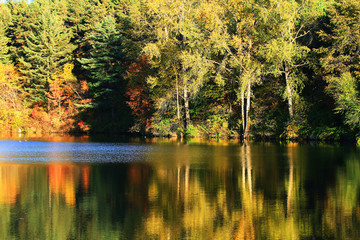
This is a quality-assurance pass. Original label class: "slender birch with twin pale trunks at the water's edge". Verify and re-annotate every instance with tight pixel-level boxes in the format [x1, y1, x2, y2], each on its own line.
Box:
[223, 1, 262, 138]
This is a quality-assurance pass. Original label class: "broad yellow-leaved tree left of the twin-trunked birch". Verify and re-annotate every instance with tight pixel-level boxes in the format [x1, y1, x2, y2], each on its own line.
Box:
[137, 1, 217, 134]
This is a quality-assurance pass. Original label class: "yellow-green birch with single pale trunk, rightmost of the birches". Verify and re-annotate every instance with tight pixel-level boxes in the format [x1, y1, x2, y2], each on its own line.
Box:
[262, 0, 310, 121]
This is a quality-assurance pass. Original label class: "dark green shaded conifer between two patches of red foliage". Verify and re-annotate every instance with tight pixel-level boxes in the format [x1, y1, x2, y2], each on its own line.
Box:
[78, 16, 129, 130]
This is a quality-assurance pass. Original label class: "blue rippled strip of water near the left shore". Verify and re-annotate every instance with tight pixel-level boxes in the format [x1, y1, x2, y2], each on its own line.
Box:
[0, 141, 150, 163]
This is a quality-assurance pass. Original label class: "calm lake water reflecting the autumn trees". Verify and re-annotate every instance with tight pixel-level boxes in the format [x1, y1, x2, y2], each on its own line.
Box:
[0, 138, 360, 239]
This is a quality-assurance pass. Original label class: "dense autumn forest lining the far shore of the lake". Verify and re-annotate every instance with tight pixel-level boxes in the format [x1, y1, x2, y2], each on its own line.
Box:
[0, 0, 360, 140]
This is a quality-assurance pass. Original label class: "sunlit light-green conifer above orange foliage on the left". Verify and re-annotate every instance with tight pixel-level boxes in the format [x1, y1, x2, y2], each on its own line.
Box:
[19, 9, 74, 103]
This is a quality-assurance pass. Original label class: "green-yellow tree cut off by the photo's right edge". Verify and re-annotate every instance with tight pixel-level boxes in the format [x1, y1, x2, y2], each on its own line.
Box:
[319, 0, 360, 133]
